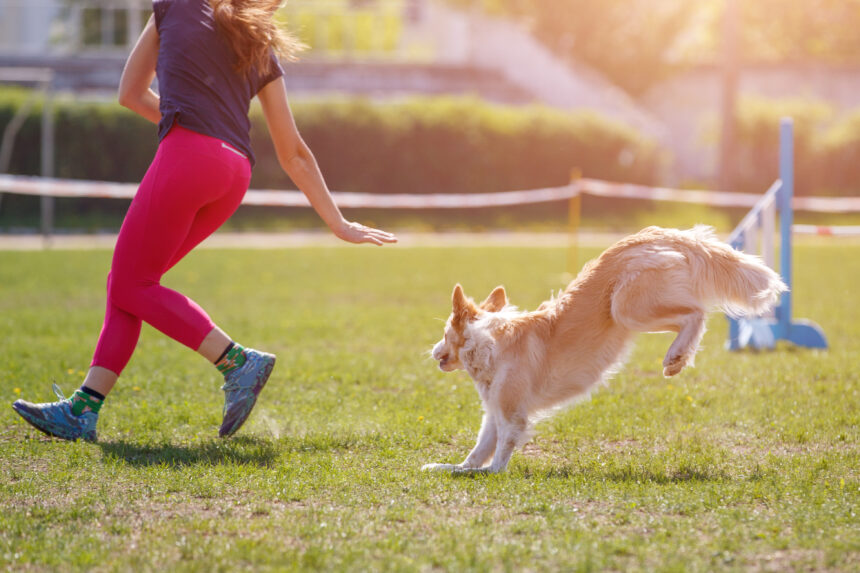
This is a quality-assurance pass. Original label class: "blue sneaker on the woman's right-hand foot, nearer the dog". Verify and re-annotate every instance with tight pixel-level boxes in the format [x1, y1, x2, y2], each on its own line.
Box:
[218, 348, 275, 438]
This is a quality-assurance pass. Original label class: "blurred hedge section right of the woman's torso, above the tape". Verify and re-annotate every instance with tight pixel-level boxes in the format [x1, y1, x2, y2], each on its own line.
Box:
[253, 98, 657, 193]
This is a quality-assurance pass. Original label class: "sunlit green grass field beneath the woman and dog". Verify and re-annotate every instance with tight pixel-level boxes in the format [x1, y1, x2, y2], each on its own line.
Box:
[0, 242, 860, 571]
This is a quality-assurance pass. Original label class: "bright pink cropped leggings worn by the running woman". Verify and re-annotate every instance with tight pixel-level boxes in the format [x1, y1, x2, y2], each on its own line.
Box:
[92, 125, 251, 375]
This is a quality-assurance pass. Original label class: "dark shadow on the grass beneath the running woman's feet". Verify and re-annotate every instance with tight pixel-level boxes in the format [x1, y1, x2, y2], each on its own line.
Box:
[98, 436, 278, 467]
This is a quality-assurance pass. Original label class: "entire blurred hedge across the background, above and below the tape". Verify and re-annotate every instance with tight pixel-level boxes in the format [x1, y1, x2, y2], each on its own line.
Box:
[0, 88, 860, 229]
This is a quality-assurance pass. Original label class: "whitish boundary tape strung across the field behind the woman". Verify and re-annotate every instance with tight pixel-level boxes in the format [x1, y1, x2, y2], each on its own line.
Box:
[0, 174, 860, 213]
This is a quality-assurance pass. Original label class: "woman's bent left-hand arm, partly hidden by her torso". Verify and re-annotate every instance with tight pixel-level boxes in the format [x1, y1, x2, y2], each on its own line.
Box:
[119, 16, 161, 124]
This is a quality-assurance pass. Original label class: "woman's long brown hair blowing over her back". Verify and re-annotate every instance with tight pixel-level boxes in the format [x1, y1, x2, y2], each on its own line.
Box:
[209, 0, 304, 74]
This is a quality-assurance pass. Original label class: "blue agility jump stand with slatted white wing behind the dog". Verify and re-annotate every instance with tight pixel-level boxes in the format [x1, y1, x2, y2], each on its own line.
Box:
[727, 118, 827, 350]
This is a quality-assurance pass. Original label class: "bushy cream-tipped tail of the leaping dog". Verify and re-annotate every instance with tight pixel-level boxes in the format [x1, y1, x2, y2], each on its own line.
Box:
[693, 227, 788, 317]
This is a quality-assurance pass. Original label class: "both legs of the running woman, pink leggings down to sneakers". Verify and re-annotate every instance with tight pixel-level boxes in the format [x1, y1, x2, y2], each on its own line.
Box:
[13, 128, 255, 441]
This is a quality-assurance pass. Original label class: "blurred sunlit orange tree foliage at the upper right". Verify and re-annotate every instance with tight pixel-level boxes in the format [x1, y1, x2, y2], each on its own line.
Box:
[448, 0, 860, 96]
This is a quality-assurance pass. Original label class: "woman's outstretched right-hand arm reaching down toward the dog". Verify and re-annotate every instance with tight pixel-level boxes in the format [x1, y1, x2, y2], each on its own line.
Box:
[257, 78, 397, 245]
